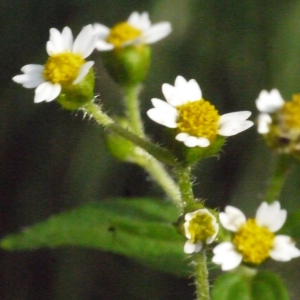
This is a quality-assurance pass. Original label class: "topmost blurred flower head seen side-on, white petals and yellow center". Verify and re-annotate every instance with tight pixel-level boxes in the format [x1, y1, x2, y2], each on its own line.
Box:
[94, 12, 172, 51]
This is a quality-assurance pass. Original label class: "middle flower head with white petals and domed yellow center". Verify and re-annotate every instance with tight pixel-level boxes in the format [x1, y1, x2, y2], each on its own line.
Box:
[147, 76, 253, 147]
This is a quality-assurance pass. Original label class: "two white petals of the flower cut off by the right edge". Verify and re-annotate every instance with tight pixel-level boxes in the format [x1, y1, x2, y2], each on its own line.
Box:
[255, 89, 284, 134]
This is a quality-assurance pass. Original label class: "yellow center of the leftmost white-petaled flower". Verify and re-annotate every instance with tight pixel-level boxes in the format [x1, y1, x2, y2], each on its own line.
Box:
[43, 52, 85, 85]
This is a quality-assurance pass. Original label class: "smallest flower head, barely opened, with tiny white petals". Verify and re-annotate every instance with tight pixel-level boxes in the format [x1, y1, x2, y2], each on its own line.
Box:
[183, 208, 219, 254]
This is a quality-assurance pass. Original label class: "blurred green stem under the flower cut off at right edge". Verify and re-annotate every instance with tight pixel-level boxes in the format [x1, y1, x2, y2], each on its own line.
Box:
[266, 154, 290, 203]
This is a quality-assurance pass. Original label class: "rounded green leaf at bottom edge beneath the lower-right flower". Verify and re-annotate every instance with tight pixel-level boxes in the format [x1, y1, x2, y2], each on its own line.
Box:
[212, 271, 289, 300]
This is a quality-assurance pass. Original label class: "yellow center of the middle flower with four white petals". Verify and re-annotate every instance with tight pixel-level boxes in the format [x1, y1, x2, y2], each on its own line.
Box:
[176, 99, 220, 141]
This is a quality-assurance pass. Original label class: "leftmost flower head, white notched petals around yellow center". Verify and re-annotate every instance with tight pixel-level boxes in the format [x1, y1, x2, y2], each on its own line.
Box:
[13, 25, 96, 103]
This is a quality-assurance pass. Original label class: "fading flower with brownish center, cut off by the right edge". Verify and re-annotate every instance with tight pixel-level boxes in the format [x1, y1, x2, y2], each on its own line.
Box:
[256, 89, 300, 156]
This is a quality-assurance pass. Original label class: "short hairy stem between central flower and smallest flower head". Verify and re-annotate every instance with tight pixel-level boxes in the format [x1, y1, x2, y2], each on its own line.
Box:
[175, 166, 195, 206]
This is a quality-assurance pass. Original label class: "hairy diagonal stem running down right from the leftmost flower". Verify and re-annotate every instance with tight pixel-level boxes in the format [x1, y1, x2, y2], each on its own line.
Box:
[82, 102, 177, 166]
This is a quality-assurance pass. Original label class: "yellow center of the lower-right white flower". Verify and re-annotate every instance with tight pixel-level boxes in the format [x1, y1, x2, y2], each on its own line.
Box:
[233, 219, 275, 264]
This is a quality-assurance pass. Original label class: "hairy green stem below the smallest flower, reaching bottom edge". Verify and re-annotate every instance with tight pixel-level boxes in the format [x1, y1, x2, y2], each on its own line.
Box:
[194, 250, 210, 300]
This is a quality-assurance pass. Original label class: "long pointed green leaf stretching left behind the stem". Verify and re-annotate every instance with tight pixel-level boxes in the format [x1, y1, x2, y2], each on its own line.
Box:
[0, 199, 188, 276]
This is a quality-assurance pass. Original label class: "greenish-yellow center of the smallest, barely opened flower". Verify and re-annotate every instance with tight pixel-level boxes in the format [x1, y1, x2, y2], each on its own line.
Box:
[187, 212, 216, 243]
